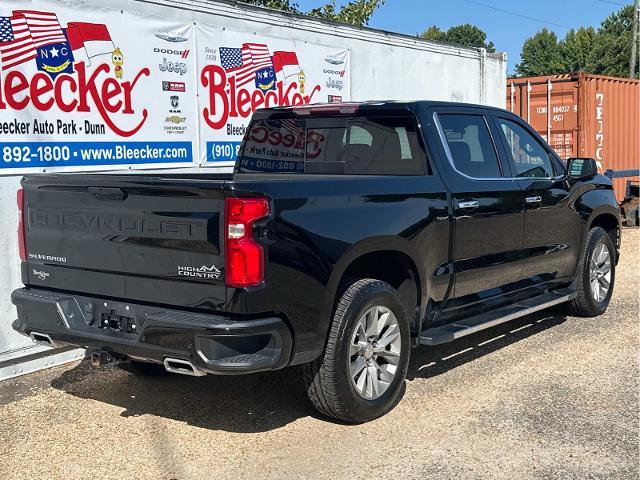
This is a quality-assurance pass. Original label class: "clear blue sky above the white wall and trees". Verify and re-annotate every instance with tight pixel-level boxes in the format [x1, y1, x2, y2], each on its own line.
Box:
[297, 0, 631, 74]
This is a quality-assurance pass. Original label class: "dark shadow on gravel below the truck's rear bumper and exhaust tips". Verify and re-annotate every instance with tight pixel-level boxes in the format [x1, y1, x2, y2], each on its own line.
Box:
[51, 360, 316, 433]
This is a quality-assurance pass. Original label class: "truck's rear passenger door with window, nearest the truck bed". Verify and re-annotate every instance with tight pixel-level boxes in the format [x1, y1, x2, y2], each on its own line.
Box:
[433, 108, 524, 300]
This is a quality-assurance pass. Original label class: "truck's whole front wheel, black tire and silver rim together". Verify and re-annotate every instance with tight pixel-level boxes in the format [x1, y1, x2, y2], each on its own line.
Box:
[568, 227, 616, 317]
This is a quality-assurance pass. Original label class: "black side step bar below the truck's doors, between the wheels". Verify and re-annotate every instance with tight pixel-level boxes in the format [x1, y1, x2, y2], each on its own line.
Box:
[420, 289, 576, 345]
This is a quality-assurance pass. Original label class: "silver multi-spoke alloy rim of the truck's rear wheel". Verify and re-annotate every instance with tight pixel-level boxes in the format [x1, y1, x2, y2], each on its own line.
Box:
[349, 305, 402, 400]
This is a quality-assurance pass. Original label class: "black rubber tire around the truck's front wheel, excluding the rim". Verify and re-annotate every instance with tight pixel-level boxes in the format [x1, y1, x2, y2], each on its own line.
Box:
[567, 227, 616, 317]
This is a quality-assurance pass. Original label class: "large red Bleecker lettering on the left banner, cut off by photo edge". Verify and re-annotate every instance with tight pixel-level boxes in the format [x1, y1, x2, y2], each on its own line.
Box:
[0, 62, 150, 137]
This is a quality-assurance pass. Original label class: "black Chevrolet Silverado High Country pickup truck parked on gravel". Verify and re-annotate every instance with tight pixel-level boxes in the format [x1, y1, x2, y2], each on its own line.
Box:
[12, 101, 620, 422]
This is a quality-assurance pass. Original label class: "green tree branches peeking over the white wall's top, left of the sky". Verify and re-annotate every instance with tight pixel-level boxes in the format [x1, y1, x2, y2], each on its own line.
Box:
[239, 0, 385, 27]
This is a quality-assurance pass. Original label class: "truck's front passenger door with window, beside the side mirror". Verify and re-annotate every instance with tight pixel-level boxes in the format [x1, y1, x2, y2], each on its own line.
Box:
[494, 114, 581, 284]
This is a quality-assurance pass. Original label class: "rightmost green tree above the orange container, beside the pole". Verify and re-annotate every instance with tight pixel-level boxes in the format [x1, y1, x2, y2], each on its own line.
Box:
[591, 5, 633, 77]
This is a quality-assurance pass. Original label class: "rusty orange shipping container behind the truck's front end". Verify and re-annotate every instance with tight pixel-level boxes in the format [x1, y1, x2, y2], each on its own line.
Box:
[506, 73, 640, 200]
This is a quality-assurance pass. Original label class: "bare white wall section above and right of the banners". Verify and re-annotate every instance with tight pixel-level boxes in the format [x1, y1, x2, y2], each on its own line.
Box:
[144, 0, 507, 107]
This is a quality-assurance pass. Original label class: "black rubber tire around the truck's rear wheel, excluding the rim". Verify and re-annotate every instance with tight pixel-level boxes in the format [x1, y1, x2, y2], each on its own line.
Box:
[303, 279, 410, 423]
